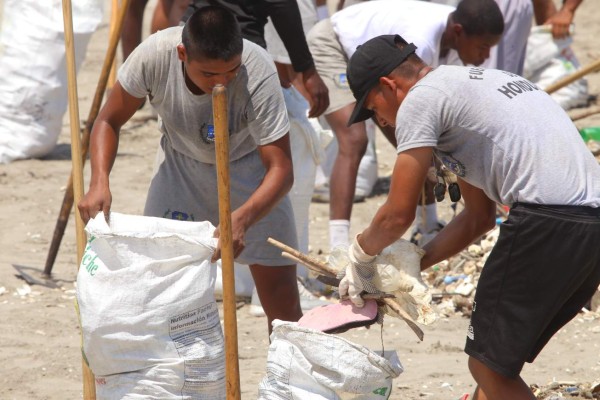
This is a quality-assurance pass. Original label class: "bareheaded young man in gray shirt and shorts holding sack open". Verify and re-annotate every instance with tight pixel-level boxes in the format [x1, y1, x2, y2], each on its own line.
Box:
[79, 7, 302, 332]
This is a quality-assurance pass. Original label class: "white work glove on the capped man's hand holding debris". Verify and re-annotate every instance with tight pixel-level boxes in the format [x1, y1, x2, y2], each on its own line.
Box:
[339, 235, 380, 307]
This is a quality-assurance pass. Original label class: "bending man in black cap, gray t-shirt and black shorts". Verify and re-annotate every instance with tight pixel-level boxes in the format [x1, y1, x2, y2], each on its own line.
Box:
[340, 35, 600, 400]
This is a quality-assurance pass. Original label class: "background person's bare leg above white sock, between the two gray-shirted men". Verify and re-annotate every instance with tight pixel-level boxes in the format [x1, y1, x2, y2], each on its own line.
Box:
[326, 103, 368, 220]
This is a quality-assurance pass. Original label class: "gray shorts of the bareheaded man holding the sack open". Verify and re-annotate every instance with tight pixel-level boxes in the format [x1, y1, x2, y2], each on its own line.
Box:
[144, 136, 298, 266]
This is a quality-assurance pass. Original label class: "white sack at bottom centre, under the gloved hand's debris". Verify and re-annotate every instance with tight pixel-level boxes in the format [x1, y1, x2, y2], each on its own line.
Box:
[258, 320, 403, 400]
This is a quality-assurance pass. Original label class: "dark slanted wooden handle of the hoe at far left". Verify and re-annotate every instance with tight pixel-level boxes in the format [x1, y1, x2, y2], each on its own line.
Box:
[43, 0, 129, 277]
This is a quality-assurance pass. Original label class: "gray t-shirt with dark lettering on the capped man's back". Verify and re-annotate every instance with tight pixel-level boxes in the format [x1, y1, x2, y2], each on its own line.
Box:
[396, 66, 600, 207]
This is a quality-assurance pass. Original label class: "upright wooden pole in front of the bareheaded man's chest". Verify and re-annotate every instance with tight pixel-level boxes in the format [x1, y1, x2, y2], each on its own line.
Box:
[212, 85, 240, 400]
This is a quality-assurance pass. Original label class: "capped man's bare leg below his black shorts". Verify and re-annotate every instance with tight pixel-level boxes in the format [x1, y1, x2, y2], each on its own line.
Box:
[469, 357, 536, 400]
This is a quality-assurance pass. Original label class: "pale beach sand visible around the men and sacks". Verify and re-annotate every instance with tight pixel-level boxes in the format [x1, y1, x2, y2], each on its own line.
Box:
[0, 0, 600, 400]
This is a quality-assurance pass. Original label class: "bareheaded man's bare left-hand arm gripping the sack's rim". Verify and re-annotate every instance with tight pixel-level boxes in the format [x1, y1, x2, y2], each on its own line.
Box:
[77, 81, 144, 223]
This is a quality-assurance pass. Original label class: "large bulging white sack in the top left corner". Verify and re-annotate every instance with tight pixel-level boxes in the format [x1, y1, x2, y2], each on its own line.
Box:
[0, 0, 103, 163]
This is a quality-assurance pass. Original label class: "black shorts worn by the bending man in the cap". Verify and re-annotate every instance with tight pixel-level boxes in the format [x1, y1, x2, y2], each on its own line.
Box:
[465, 203, 600, 378]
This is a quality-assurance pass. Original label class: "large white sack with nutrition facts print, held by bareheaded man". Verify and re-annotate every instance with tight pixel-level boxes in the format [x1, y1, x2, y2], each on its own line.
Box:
[77, 212, 225, 399]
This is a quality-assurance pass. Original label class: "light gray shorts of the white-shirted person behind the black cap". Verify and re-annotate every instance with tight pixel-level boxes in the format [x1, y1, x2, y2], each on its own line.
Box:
[306, 18, 356, 115]
